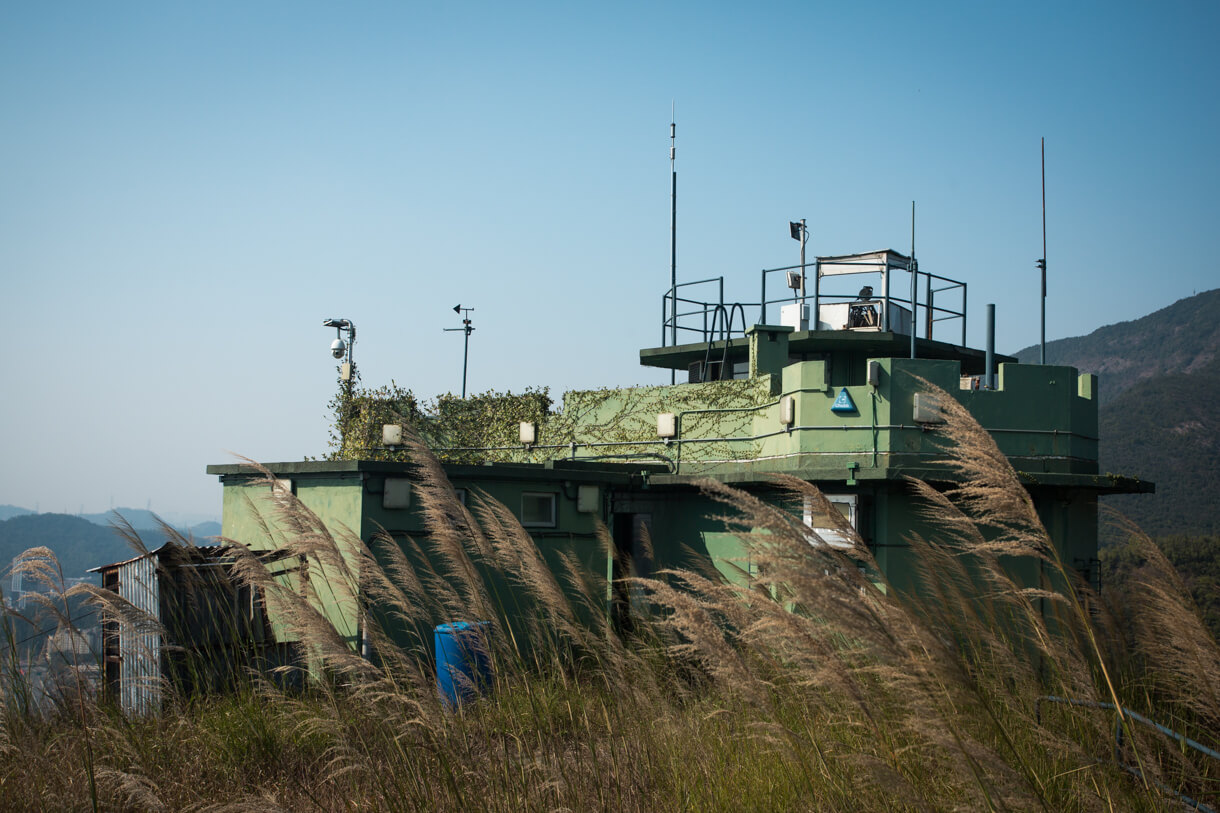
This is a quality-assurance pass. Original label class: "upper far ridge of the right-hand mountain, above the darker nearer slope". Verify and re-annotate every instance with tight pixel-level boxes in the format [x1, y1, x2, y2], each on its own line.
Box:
[1016, 288, 1220, 405]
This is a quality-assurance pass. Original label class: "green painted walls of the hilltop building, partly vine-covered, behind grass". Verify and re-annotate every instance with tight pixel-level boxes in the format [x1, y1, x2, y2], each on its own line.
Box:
[212, 327, 1117, 659]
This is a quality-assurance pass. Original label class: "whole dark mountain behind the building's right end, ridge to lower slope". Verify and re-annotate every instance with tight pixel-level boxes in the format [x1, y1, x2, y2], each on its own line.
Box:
[1016, 289, 1220, 536]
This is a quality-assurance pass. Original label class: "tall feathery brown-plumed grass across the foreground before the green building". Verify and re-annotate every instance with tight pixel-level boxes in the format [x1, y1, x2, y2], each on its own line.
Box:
[0, 399, 1220, 811]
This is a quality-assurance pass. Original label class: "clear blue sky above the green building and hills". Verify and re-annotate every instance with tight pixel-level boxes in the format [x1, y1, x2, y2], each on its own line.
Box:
[0, 1, 1220, 518]
